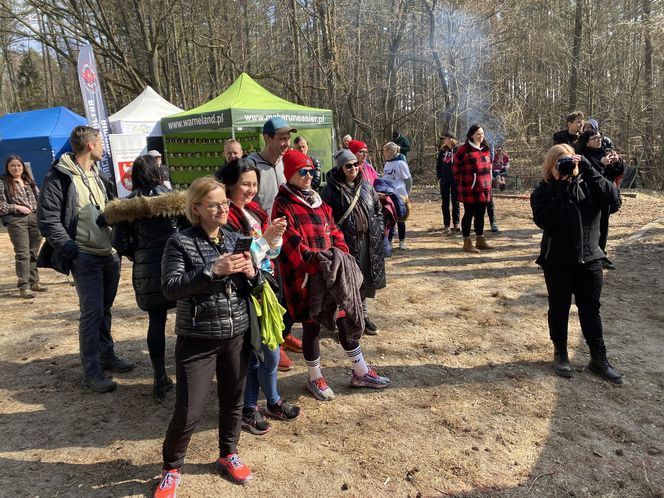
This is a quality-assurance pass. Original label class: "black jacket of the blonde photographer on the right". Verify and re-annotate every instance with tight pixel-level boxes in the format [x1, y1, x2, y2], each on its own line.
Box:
[530, 160, 621, 266]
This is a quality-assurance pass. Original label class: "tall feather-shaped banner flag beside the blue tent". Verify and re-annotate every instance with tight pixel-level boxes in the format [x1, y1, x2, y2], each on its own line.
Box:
[78, 44, 115, 180]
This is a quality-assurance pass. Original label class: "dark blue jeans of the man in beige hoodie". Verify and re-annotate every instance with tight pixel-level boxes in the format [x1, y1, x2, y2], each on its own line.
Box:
[71, 252, 120, 376]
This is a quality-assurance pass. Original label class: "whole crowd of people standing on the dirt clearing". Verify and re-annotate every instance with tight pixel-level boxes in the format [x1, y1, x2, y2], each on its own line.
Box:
[0, 113, 622, 498]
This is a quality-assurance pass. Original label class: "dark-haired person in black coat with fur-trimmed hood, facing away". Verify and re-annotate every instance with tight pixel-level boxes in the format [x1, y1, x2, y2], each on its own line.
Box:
[104, 155, 189, 399]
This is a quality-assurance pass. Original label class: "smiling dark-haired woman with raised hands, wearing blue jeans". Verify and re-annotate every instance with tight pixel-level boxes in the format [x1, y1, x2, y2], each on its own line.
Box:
[221, 159, 300, 435]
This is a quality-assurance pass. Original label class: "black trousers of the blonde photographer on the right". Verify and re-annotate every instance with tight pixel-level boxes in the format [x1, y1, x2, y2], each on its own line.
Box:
[544, 260, 604, 351]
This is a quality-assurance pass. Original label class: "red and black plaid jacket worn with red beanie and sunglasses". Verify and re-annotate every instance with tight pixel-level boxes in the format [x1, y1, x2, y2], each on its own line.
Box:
[272, 185, 348, 322]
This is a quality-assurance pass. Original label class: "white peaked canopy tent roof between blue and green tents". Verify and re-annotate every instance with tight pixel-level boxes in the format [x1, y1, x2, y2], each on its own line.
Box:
[108, 86, 183, 137]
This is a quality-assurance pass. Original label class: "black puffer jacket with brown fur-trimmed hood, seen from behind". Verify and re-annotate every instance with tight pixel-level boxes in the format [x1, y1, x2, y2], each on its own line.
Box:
[104, 185, 189, 311]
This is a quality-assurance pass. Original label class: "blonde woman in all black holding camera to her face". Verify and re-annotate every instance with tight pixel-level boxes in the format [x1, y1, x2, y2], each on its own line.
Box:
[530, 144, 622, 384]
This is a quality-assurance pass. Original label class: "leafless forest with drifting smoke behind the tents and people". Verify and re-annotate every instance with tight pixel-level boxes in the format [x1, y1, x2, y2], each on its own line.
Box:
[0, 0, 664, 188]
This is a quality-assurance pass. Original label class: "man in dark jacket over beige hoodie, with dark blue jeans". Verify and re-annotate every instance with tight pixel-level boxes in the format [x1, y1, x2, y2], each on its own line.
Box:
[37, 126, 134, 393]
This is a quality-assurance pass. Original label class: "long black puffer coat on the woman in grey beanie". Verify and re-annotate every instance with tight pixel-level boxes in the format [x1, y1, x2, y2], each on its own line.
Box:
[321, 168, 386, 289]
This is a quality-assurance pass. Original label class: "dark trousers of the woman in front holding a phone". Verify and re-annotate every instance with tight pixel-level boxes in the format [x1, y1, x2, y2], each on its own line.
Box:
[163, 334, 250, 470]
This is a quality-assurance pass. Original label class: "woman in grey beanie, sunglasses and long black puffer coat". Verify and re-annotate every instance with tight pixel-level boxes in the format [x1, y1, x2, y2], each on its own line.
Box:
[321, 149, 385, 335]
